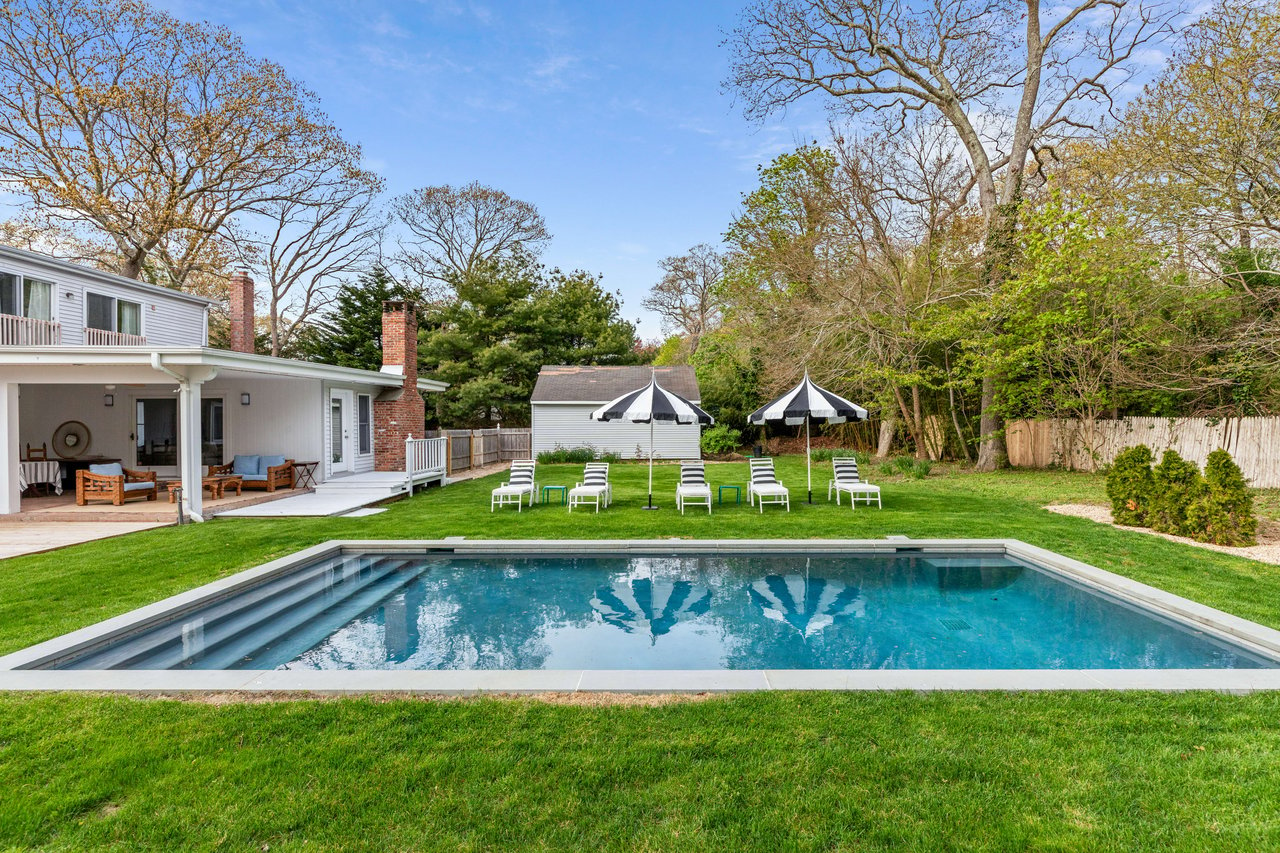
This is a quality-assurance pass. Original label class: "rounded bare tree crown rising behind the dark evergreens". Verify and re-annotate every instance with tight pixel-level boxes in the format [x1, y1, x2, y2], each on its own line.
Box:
[392, 182, 552, 289]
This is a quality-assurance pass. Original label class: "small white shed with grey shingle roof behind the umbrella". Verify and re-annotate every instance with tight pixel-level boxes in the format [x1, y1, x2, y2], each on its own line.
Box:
[530, 365, 701, 459]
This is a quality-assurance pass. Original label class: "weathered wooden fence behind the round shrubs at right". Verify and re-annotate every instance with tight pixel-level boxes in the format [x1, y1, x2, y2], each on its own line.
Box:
[1005, 418, 1280, 489]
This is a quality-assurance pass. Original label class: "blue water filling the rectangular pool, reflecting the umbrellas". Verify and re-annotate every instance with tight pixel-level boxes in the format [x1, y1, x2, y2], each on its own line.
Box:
[59, 555, 1276, 670]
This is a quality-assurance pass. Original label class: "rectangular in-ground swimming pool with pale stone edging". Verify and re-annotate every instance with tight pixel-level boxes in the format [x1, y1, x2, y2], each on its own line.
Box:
[0, 540, 1280, 685]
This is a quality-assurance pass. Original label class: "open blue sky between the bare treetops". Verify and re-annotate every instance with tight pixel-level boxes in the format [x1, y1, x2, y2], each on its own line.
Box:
[157, 0, 826, 338]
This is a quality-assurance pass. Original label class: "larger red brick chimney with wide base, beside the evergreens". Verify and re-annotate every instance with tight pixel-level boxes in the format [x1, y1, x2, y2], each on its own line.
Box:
[374, 300, 426, 471]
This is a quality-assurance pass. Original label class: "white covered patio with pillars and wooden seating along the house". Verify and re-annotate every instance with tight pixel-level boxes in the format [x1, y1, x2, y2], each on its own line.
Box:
[0, 347, 439, 523]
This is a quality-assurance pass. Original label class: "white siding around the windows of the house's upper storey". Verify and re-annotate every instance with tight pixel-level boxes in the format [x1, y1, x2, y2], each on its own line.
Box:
[0, 255, 207, 347]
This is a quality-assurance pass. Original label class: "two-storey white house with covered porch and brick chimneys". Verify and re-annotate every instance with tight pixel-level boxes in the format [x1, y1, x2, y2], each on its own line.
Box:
[0, 246, 447, 520]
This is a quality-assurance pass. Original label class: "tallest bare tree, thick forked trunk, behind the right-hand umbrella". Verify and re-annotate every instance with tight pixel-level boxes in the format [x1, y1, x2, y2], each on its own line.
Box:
[727, 0, 1172, 470]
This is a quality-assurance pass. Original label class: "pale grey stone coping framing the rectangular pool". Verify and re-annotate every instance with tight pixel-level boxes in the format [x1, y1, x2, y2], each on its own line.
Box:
[0, 537, 1280, 695]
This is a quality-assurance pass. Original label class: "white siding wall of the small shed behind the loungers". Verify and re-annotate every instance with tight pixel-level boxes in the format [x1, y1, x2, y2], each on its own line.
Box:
[531, 401, 701, 460]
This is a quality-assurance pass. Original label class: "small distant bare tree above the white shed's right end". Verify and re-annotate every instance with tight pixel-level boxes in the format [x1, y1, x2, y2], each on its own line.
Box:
[643, 243, 724, 356]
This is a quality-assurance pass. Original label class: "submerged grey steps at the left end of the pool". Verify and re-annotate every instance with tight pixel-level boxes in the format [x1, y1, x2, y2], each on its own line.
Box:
[73, 557, 412, 670]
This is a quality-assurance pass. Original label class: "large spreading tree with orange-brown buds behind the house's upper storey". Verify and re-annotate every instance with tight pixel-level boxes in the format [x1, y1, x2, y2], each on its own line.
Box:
[0, 0, 360, 287]
